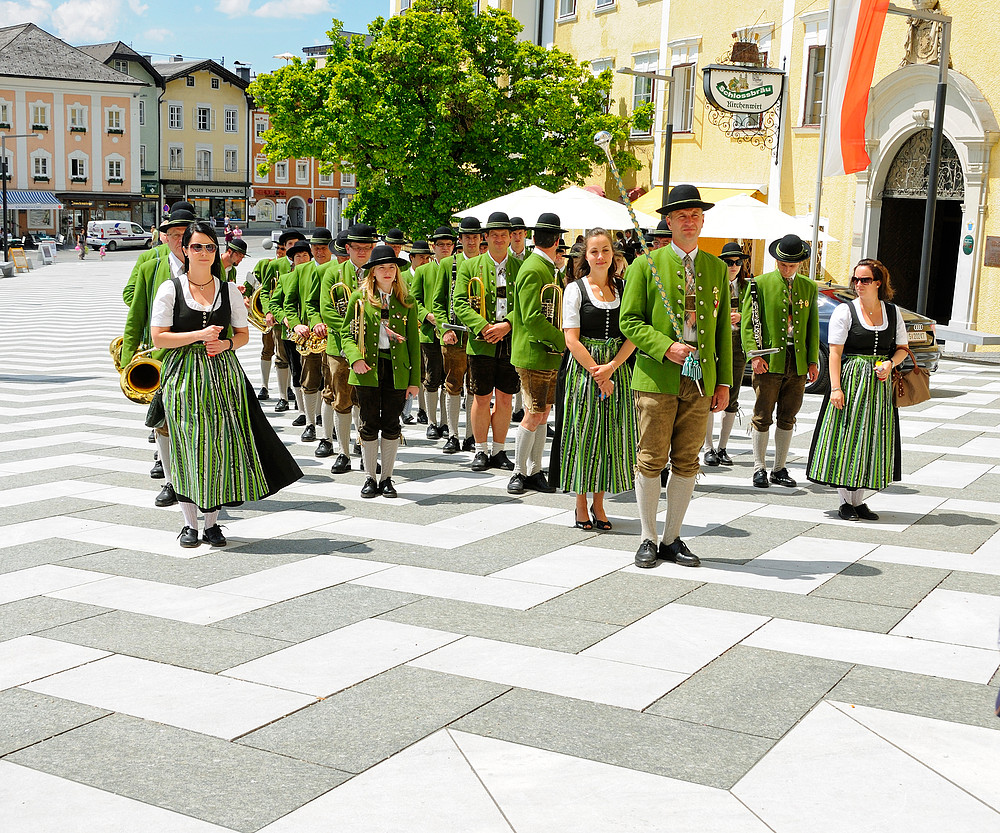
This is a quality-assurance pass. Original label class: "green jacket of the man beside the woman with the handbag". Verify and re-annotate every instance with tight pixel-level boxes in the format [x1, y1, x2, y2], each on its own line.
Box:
[740, 269, 819, 376]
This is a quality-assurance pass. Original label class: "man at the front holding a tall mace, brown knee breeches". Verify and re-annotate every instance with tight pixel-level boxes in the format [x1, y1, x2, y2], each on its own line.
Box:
[620, 185, 733, 567]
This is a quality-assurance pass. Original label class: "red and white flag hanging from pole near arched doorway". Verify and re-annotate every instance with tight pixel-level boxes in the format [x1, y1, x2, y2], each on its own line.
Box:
[823, 0, 889, 176]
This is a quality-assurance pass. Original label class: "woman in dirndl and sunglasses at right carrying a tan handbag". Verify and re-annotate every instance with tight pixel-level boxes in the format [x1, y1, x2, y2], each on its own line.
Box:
[806, 258, 907, 521]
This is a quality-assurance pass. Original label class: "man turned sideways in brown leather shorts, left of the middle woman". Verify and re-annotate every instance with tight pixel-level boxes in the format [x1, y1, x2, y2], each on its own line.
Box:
[507, 213, 566, 495]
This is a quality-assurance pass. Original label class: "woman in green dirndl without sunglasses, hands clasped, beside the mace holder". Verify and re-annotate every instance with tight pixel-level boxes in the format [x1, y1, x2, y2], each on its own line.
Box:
[550, 228, 639, 531]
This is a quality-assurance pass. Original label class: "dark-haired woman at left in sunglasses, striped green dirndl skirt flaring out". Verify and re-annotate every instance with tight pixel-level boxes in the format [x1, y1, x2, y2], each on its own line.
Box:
[150, 221, 302, 547]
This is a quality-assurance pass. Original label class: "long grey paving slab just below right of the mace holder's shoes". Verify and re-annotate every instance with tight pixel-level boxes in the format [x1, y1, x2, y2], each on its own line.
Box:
[684, 584, 910, 633]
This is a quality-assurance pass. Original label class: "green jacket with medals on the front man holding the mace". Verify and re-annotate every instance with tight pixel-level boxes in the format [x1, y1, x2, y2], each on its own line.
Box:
[619, 246, 733, 396]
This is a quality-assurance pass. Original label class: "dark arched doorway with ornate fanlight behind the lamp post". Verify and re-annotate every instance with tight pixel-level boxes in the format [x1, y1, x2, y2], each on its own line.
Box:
[877, 129, 965, 324]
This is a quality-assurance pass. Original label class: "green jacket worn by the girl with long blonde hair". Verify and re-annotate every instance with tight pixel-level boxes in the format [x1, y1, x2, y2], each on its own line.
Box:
[340, 289, 420, 390]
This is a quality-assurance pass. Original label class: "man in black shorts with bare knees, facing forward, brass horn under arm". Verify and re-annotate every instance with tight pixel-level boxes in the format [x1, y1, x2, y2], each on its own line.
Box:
[452, 211, 521, 471]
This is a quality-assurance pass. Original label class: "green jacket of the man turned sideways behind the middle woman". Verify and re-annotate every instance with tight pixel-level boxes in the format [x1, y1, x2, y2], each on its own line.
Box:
[507, 252, 566, 370]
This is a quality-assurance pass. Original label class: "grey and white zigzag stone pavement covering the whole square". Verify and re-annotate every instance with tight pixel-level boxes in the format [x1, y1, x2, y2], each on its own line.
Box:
[0, 255, 1000, 833]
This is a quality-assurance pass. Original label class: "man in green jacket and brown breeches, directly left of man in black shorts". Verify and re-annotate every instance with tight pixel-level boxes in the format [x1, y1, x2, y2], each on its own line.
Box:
[424, 217, 483, 454]
